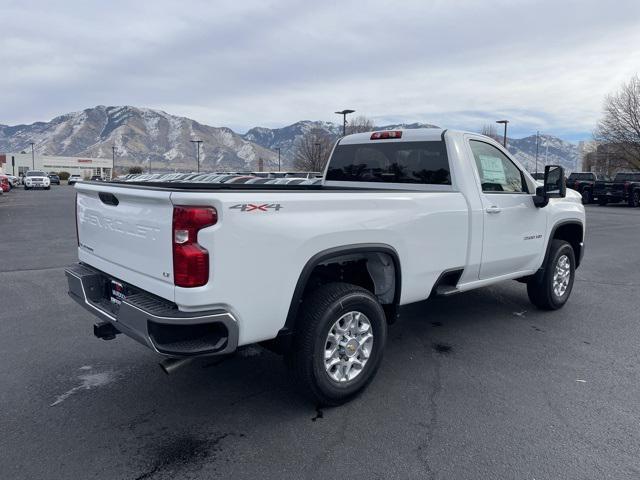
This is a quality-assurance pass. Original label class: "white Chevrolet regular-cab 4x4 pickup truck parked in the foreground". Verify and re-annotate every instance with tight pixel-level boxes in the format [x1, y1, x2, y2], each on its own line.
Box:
[66, 129, 585, 404]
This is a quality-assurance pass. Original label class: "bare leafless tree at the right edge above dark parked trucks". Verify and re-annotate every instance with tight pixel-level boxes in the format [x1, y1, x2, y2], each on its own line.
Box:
[593, 74, 640, 170]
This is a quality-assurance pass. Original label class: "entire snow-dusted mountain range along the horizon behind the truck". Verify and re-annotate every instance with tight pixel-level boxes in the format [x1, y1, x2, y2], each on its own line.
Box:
[0, 105, 578, 171]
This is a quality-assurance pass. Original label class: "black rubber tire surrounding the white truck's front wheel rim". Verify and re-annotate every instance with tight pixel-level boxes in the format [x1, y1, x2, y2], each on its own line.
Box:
[527, 240, 576, 310]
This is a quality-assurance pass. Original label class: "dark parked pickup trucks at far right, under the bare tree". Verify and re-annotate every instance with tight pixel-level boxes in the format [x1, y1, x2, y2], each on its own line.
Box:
[567, 172, 640, 207]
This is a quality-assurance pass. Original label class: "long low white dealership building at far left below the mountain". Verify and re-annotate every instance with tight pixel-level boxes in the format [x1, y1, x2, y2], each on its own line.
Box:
[0, 152, 113, 179]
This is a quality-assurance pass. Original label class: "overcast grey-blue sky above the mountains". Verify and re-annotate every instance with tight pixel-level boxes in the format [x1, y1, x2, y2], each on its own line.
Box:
[0, 0, 640, 140]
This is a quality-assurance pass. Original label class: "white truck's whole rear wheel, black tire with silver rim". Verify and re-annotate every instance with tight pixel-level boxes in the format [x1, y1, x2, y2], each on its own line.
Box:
[285, 283, 387, 405]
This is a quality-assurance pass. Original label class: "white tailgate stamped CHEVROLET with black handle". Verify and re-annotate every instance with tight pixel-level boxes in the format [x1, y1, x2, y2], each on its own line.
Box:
[76, 183, 174, 300]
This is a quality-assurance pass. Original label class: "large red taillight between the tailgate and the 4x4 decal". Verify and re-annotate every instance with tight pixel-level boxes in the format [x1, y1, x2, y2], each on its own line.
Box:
[173, 206, 218, 288]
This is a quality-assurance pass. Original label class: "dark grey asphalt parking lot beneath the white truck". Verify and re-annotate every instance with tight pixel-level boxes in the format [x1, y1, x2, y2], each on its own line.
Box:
[0, 186, 640, 480]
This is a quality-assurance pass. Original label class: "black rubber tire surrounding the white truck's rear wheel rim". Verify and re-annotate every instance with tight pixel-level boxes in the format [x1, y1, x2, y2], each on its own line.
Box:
[285, 283, 387, 406]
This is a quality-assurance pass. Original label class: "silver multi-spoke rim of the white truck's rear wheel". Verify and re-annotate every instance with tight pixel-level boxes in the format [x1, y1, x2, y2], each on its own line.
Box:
[324, 312, 373, 383]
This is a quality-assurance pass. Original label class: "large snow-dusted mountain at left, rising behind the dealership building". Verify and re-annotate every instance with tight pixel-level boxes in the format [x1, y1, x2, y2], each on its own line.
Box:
[0, 105, 277, 170]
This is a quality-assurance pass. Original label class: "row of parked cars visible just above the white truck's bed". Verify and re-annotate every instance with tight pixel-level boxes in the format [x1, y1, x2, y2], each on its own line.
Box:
[115, 172, 322, 185]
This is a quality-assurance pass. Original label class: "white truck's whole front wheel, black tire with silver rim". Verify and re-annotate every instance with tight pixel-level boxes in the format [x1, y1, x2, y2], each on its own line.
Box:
[527, 240, 576, 310]
